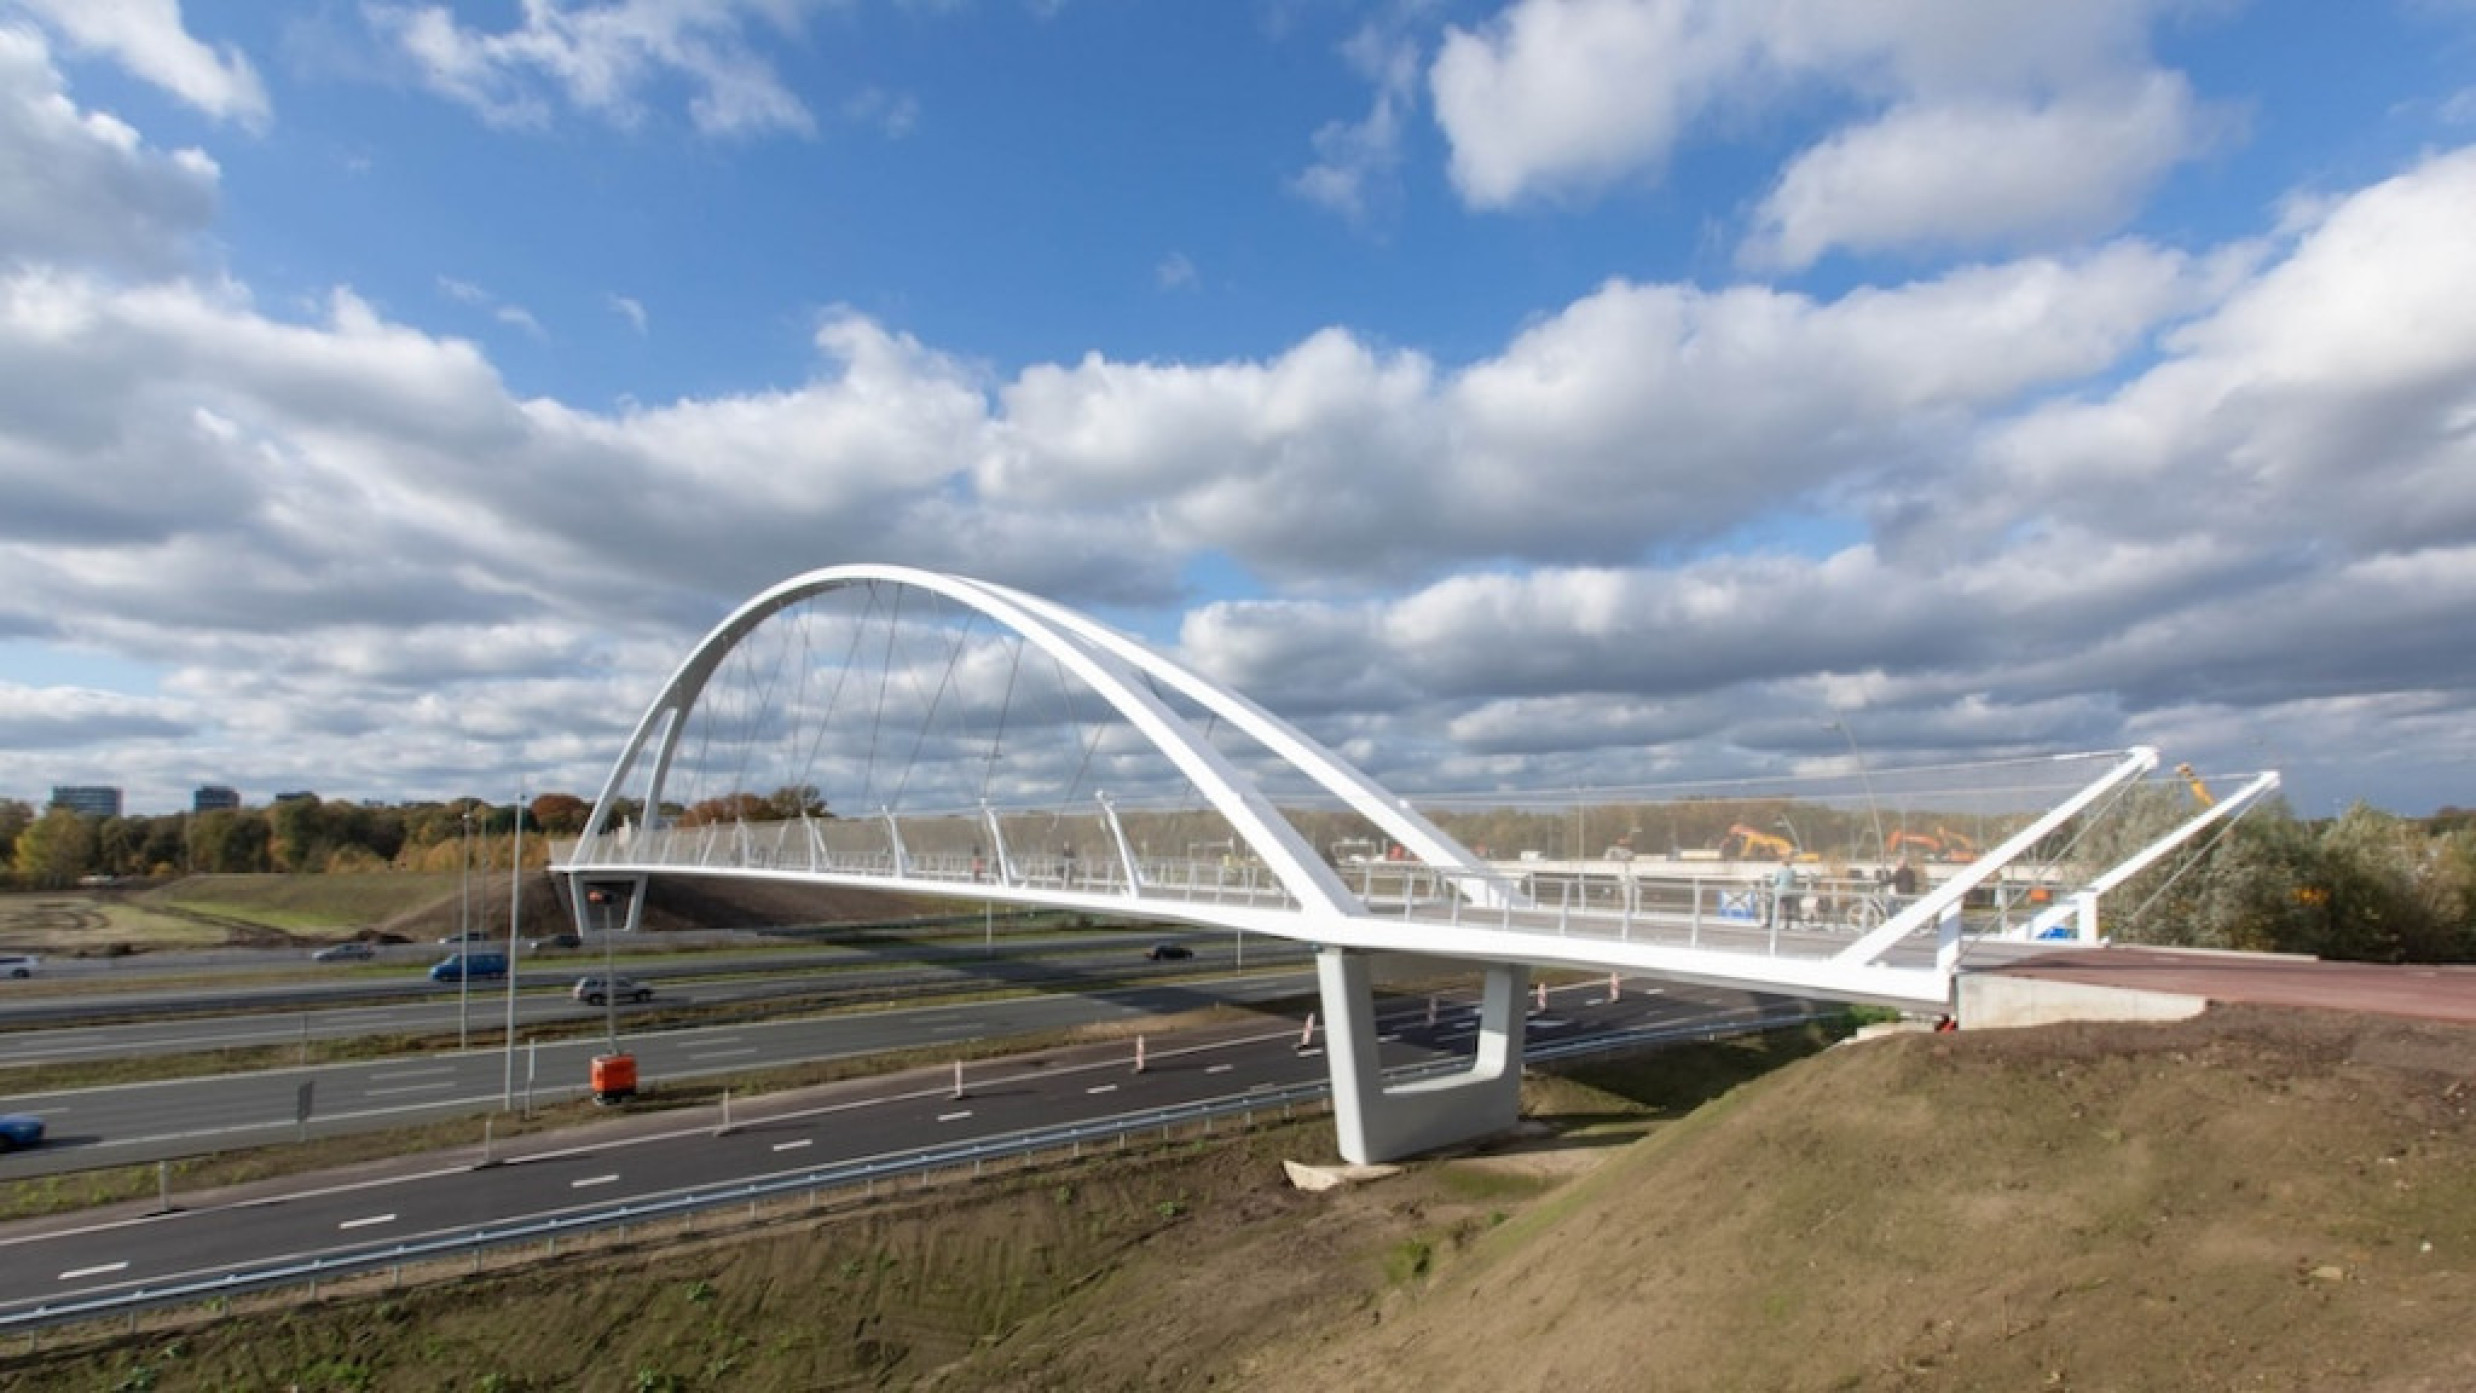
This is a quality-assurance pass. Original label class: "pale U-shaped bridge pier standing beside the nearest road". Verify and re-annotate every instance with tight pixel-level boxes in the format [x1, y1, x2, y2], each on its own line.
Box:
[1315, 948, 1530, 1165]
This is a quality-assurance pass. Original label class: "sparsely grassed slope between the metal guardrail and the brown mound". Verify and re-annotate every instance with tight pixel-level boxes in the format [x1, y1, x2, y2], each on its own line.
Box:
[0, 1032, 1820, 1391]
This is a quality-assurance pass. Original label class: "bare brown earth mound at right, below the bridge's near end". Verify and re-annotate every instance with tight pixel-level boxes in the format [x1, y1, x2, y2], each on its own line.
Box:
[1283, 1009, 2476, 1393]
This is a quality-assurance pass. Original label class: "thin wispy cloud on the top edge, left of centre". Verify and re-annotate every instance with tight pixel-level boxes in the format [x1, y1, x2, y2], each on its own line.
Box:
[366, 0, 817, 136]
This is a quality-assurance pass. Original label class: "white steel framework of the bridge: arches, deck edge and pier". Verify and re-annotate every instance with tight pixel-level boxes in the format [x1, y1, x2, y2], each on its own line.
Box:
[555, 564, 2157, 1163]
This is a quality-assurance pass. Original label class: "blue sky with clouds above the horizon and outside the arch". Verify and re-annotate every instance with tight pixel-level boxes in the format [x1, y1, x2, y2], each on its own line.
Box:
[0, 0, 2476, 817]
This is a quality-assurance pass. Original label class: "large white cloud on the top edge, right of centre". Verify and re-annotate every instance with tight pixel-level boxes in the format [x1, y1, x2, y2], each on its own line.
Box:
[1429, 0, 2223, 267]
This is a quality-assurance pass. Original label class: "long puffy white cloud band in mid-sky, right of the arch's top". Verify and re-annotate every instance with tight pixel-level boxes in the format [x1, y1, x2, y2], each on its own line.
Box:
[980, 245, 2196, 584]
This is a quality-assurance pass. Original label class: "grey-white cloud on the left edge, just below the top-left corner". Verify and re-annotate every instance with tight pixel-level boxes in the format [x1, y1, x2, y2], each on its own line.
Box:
[0, 25, 220, 275]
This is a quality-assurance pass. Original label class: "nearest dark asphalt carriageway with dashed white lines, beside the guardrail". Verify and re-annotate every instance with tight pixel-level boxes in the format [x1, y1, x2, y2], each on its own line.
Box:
[0, 987, 1807, 1311]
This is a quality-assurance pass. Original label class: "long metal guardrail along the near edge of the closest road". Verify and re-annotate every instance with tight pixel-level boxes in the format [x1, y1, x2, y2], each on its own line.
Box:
[0, 1012, 1830, 1334]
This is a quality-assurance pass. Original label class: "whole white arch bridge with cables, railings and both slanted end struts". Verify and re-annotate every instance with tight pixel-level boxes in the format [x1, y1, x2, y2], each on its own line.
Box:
[552, 564, 2275, 1160]
